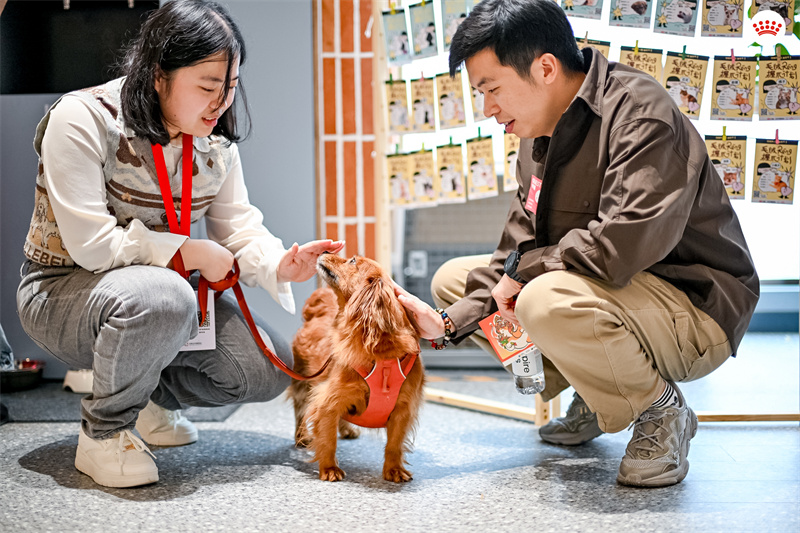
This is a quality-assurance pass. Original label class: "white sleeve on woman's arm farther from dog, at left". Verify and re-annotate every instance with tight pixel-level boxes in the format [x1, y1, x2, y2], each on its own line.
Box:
[41, 96, 186, 272]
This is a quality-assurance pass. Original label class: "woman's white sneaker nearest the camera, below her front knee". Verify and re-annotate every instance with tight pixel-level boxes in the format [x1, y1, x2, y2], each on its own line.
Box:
[75, 427, 158, 487]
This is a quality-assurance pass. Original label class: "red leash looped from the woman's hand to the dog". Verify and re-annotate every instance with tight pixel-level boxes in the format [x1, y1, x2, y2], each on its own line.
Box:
[172, 256, 331, 381]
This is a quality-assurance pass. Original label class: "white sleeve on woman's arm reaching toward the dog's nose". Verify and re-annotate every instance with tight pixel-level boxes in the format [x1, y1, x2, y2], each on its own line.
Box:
[205, 144, 295, 314]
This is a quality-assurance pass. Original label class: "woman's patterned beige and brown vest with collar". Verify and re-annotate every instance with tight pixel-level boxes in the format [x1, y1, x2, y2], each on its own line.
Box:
[24, 78, 231, 266]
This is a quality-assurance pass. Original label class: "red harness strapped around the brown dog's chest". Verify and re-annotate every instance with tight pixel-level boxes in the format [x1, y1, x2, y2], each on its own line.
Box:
[342, 353, 417, 428]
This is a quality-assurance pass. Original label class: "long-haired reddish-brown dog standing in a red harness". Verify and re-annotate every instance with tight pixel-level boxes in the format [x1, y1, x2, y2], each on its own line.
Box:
[289, 254, 425, 483]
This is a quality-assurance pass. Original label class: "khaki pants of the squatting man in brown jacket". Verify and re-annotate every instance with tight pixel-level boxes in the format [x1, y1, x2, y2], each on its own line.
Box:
[431, 255, 732, 433]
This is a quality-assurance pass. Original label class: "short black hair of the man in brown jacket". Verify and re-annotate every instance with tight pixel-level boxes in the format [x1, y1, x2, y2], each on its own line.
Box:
[450, 0, 583, 80]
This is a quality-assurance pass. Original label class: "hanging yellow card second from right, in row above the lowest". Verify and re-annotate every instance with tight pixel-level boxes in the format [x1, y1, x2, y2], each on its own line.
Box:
[711, 56, 758, 120]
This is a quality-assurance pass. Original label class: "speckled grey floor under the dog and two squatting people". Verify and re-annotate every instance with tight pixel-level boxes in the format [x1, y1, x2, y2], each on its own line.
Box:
[0, 334, 800, 533]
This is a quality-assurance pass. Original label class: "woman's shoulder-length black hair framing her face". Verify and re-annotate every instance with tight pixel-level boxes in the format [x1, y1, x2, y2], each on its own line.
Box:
[120, 0, 250, 145]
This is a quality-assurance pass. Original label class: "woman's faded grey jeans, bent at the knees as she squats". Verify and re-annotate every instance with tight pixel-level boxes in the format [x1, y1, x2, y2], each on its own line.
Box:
[17, 262, 292, 439]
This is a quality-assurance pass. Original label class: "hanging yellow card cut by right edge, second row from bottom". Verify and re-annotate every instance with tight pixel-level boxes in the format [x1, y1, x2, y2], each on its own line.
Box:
[758, 56, 800, 120]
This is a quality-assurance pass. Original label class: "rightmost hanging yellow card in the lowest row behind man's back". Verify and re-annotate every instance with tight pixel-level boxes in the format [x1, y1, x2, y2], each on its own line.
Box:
[753, 139, 797, 204]
